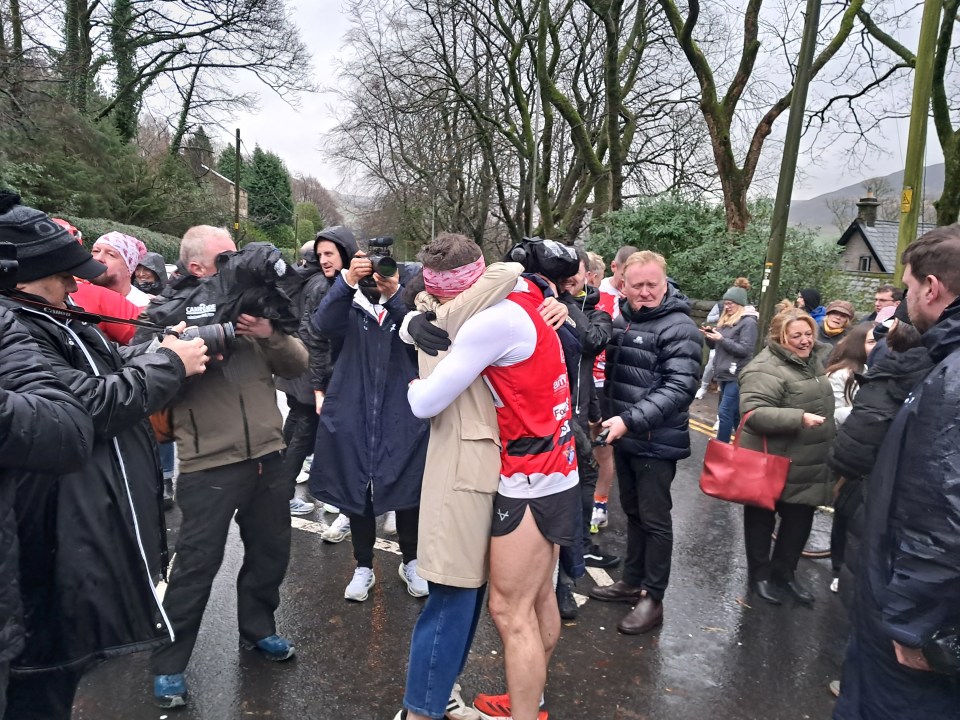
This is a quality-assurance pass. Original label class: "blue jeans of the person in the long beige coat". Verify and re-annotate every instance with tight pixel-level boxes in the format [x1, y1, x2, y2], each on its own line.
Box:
[403, 583, 486, 718]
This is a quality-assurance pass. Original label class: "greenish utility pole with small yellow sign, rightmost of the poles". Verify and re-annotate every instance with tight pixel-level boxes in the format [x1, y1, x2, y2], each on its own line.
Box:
[893, 0, 942, 284]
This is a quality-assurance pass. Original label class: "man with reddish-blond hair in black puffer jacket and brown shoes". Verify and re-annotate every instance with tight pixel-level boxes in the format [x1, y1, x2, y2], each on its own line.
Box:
[590, 251, 702, 635]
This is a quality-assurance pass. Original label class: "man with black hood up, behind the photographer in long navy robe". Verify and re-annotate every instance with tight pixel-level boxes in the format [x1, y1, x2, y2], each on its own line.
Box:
[277, 225, 357, 515]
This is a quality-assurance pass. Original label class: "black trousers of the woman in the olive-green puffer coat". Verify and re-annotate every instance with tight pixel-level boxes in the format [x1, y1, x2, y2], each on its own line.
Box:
[743, 502, 816, 580]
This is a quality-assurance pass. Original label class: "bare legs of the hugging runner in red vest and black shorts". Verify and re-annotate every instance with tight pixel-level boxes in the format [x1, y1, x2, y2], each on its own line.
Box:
[490, 508, 560, 720]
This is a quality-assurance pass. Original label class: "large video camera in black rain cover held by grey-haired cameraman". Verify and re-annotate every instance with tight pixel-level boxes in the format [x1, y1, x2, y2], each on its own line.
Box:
[147, 242, 303, 335]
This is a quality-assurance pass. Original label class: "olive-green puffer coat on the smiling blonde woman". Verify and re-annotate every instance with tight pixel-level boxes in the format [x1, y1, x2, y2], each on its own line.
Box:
[740, 343, 836, 505]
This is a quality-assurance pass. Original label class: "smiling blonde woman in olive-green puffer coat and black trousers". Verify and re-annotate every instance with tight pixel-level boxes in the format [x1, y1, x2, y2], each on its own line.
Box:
[740, 308, 835, 605]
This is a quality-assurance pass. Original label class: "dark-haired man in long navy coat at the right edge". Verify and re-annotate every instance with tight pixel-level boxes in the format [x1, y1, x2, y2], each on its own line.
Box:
[834, 225, 960, 720]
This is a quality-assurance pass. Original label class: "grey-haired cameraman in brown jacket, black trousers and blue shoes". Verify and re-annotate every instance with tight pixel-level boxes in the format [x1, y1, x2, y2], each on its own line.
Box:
[147, 225, 307, 707]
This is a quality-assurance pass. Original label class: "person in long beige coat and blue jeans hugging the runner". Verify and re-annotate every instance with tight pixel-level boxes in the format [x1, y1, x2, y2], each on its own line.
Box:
[396, 243, 523, 720]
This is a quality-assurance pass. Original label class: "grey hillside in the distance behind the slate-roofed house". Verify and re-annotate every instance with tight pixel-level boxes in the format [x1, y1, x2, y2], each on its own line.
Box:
[790, 163, 943, 232]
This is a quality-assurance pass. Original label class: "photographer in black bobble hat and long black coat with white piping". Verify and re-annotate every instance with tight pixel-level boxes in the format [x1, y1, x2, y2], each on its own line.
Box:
[0, 193, 207, 720]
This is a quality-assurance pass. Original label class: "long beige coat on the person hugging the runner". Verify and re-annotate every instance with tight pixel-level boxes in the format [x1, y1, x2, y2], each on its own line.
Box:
[417, 263, 523, 588]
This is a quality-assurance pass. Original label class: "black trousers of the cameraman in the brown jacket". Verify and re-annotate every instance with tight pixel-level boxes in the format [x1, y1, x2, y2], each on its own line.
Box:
[150, 453, 290, 675]
